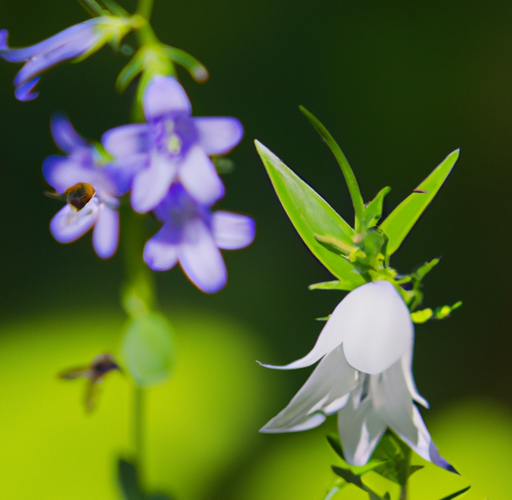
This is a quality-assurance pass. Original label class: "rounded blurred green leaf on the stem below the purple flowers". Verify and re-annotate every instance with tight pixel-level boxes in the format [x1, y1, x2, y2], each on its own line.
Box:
[121, 312, 175, 387]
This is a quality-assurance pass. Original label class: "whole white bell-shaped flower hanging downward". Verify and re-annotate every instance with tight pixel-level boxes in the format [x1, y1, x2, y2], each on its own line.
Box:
[261, 282, 453, 470]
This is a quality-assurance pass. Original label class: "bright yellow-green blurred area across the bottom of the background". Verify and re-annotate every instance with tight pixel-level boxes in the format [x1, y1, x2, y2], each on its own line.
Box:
[0, 310, 512, 500]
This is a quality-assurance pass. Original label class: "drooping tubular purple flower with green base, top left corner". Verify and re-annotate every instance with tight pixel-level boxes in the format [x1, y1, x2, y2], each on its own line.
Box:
[0, 16, 132, 101]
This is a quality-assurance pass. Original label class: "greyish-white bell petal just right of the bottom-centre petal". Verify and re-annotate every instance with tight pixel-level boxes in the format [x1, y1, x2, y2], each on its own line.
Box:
[370, 360, 418, 442]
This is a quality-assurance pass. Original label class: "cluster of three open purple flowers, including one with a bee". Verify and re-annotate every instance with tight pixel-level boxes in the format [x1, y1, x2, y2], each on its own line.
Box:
[43, 76, 254, 293]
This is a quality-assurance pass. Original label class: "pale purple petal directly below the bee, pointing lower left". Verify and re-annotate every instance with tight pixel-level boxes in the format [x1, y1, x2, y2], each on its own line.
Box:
[50, 199, 98, 243]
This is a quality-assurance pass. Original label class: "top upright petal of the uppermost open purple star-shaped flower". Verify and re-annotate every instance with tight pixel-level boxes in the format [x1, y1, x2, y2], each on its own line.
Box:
[143, 76, 192, 121]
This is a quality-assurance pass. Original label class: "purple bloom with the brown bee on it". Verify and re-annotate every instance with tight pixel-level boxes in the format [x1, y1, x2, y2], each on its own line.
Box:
[43, 117, 131, 259]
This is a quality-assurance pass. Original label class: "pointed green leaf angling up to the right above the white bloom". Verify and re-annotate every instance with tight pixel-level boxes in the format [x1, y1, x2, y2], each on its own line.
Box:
[380, 149, 459, 255]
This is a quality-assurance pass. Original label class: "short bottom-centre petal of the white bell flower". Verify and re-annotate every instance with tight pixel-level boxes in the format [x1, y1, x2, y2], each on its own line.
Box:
[338, 398, 386, 465]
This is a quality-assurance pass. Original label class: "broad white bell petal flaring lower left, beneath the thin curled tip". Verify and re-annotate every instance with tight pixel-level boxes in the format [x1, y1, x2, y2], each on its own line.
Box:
[260, 346, 357, 433]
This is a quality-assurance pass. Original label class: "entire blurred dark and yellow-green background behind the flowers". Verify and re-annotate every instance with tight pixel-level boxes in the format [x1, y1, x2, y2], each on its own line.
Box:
[0, 0, 512, 500]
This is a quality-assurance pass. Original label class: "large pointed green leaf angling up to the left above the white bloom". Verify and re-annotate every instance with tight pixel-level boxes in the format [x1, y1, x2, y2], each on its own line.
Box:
[255, 141, 365, 286]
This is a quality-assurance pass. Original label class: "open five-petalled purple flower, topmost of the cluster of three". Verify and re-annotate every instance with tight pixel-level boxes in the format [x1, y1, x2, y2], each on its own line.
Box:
[103, 76, 243, 213]
